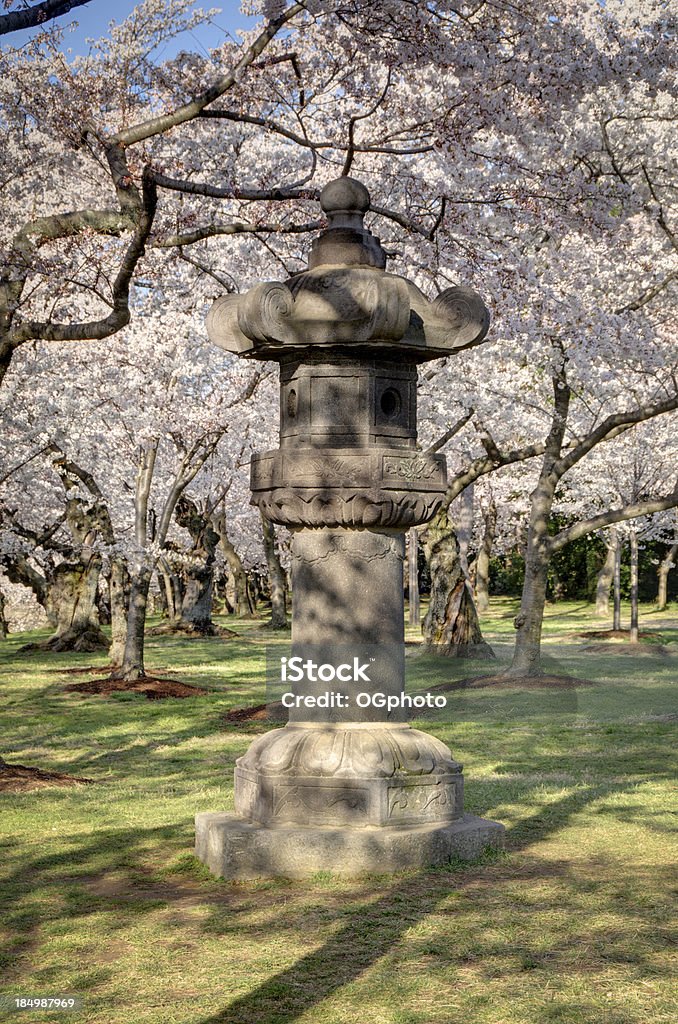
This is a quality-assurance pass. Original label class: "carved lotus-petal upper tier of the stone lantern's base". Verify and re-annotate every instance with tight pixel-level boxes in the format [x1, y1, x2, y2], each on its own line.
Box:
[236, 722, 464, 827]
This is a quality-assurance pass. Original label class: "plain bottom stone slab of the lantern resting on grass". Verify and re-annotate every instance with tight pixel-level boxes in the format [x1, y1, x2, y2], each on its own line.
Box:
[196, 811, 505, 881]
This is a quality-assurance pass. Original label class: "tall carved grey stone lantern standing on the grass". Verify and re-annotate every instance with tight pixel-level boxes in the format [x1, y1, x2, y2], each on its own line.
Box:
[196, 177, 504, 879]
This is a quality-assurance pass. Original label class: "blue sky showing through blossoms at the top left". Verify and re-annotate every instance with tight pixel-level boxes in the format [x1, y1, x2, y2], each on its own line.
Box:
[7, 0, 255, 58]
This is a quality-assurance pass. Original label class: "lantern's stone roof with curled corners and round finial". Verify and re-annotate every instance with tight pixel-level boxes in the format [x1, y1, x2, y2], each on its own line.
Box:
[207, 176, 490, 362]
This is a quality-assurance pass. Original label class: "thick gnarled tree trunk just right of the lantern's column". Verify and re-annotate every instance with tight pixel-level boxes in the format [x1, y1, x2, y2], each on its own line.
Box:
[422, 510, 495, 657]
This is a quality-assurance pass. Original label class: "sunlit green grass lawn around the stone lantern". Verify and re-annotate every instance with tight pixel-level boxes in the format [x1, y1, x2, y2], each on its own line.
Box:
[0, 600, 678, 1024]
